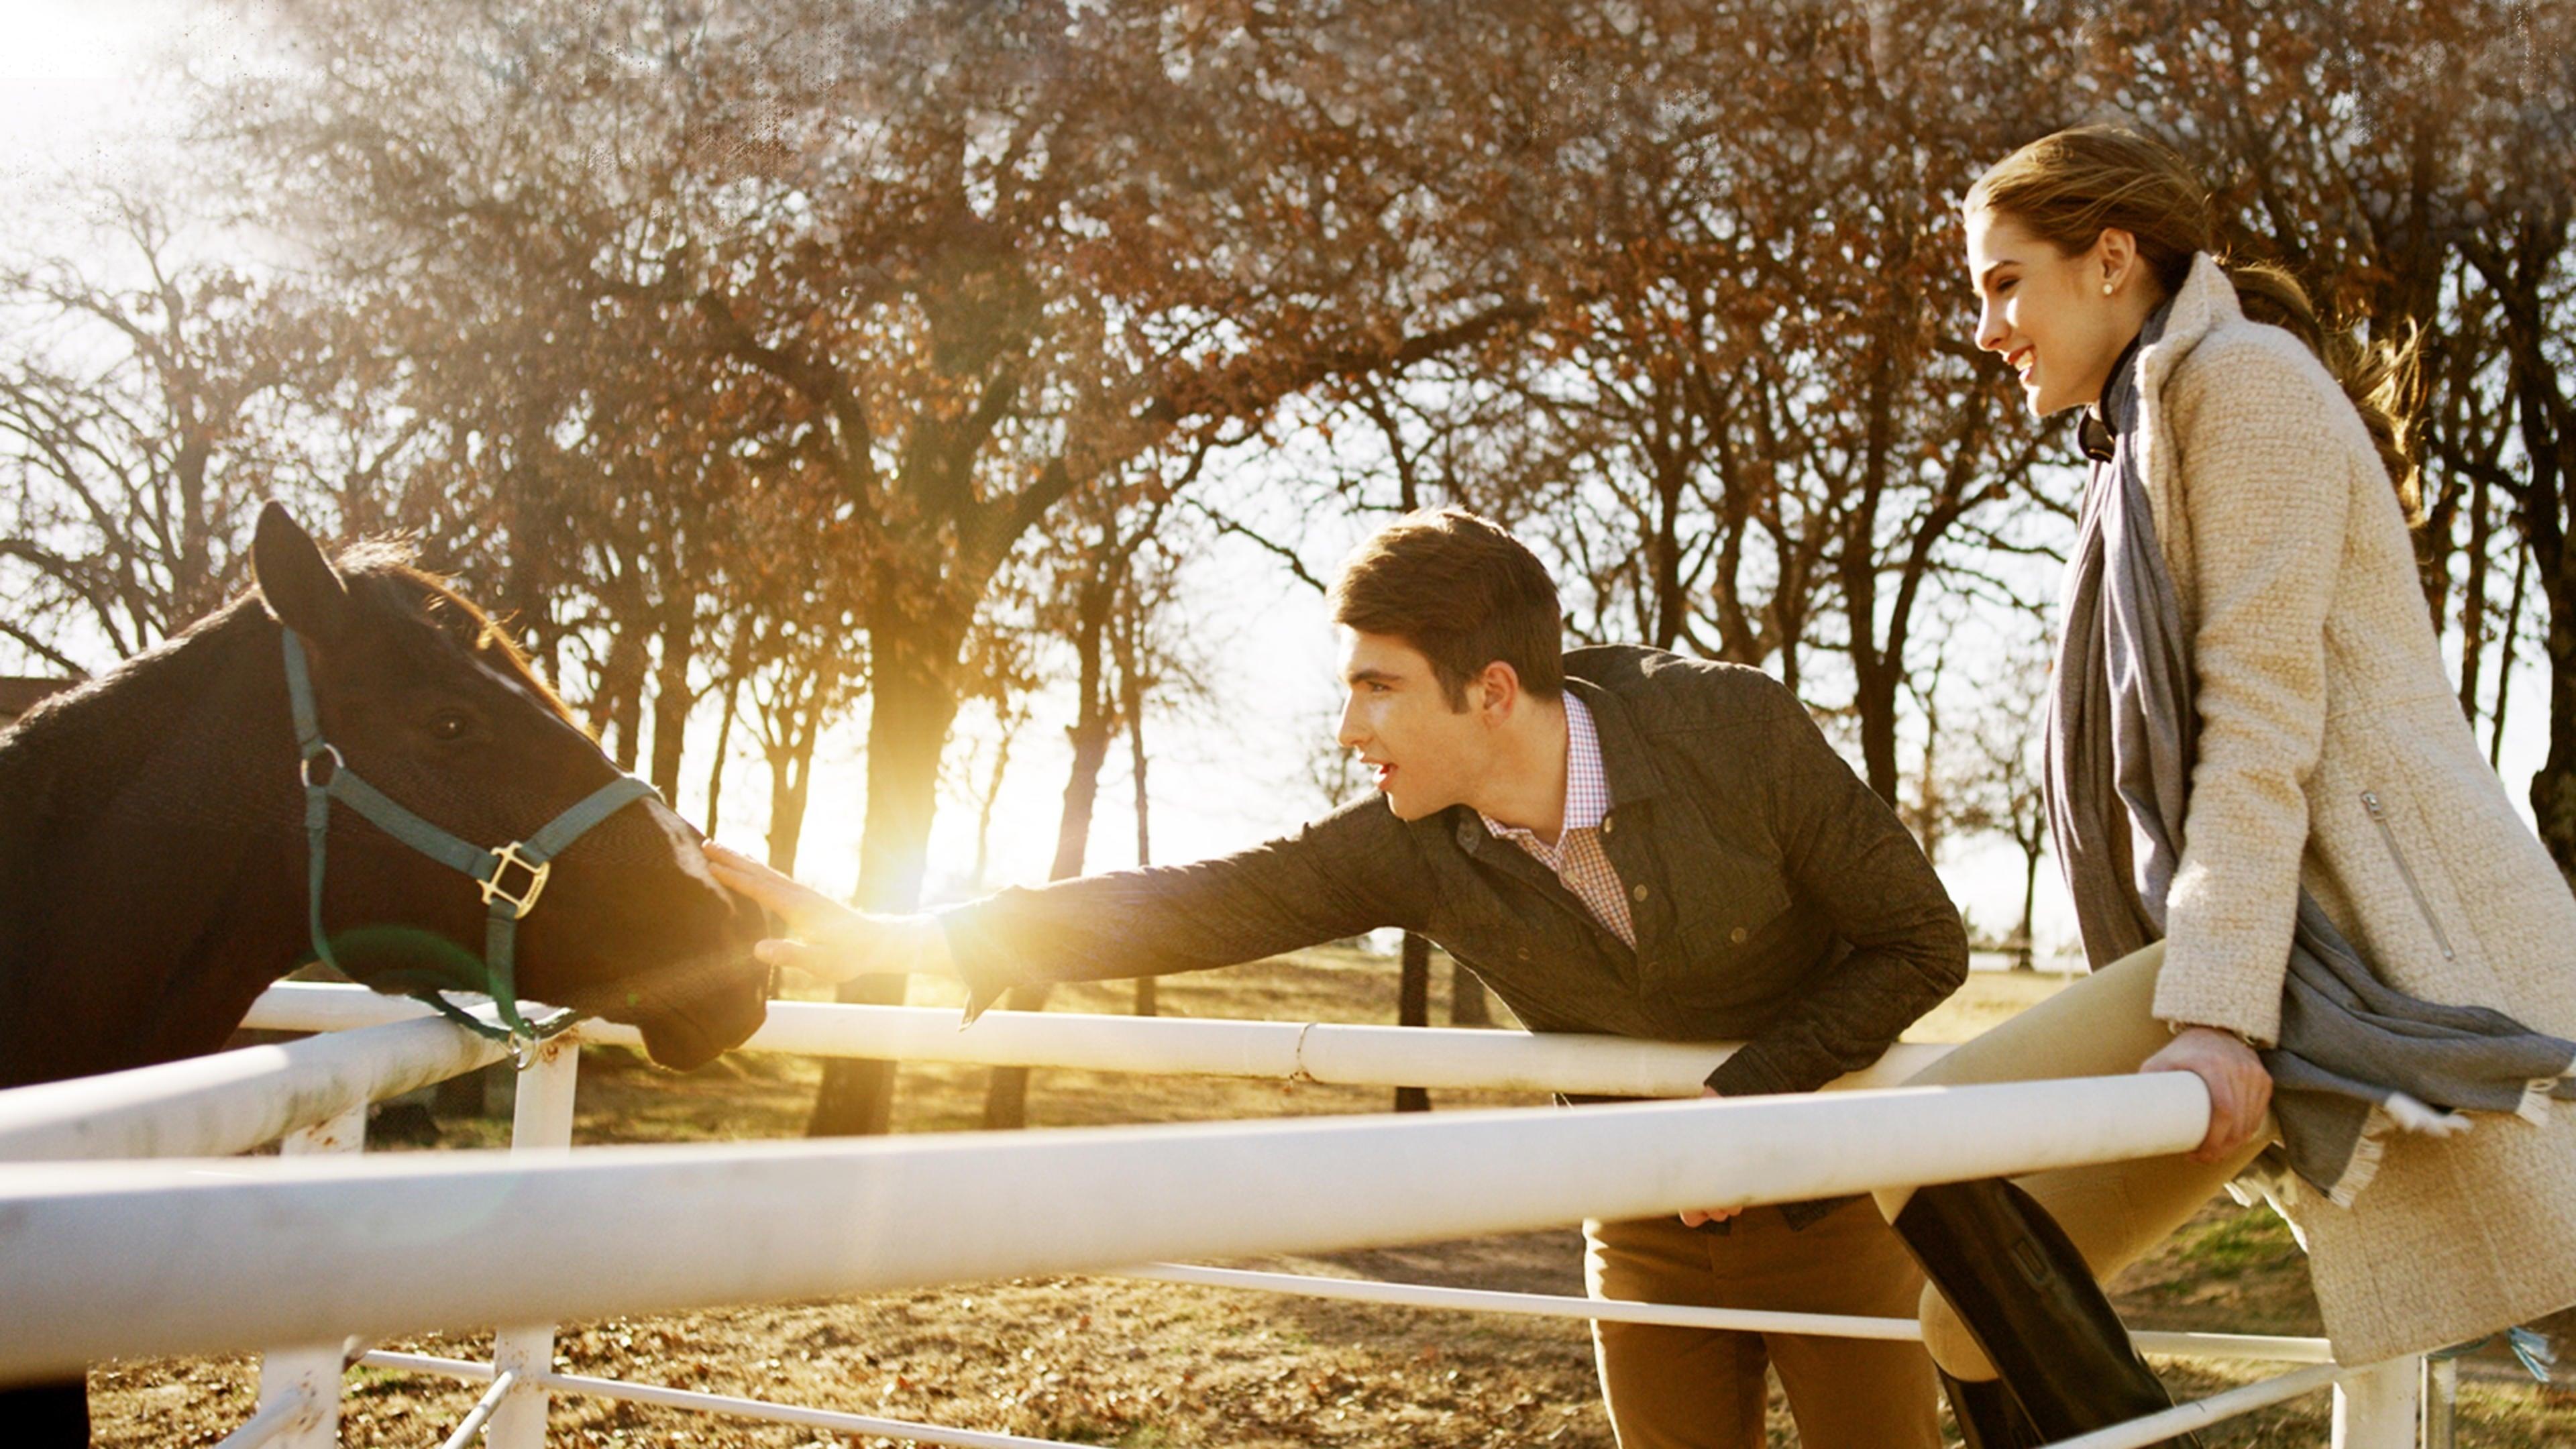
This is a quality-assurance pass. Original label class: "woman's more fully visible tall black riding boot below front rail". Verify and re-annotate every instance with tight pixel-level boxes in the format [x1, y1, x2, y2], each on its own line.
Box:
[1896, 1178, 2200, 1449]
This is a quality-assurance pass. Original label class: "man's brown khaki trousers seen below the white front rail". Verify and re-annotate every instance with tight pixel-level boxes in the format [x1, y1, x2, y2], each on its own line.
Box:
[1585, 1201, 1940, 1449]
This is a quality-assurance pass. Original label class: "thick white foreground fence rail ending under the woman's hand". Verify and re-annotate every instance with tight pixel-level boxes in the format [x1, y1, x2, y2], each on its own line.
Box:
[0, 1073, 2208, 1375]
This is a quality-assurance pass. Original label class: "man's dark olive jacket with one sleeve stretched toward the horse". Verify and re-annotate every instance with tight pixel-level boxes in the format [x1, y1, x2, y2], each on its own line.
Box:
[945, 637, 1968, 1095]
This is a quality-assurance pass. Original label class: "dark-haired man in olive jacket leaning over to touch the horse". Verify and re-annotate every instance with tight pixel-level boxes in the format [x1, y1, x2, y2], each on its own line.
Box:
[711, 511, 1968, 1449]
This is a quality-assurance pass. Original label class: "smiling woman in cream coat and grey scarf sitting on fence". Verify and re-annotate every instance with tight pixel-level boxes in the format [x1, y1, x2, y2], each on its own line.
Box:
[1880, 126, 2576, 1446]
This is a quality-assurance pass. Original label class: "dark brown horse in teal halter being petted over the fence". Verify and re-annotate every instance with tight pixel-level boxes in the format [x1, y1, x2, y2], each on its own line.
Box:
[0, 502, 767, 1444]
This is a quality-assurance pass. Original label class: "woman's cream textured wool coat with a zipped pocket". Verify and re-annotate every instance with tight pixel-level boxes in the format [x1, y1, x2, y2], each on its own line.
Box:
[2138, 255, 2576, 1364]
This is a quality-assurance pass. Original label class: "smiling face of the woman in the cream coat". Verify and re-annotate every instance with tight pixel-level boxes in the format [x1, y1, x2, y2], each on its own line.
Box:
[1966, 206, 2156, 418]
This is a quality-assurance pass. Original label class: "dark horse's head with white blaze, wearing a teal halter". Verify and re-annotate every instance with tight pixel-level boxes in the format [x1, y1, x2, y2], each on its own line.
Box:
[252, 502, 767, 1067]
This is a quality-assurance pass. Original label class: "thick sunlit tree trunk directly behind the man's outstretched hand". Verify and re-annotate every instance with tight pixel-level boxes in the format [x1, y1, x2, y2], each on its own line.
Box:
[806, 626, 963, 1137]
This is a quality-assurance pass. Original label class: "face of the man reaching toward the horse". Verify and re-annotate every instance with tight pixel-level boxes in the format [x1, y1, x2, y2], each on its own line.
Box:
[1340, 629, 1494, 820]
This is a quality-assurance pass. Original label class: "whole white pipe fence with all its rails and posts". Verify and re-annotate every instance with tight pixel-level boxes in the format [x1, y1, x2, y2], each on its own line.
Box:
[0, 985, 2422, 1449]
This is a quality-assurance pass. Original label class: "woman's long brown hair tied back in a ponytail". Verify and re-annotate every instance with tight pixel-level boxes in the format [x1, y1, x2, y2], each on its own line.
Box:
[1960, 126, 2424, 523]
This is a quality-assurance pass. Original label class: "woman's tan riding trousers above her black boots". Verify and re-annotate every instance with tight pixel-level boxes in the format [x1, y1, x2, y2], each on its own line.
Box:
[1878, 941, 2272, 1379]
